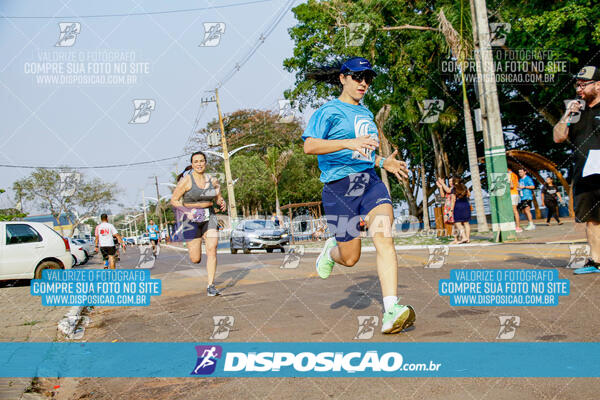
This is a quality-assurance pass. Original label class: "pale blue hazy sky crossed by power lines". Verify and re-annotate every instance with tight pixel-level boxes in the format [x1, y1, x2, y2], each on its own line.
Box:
[0, 0, 300, 212]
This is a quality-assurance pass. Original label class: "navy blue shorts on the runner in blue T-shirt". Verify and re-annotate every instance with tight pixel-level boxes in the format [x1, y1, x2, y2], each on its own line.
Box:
[322, 169, 392, 242]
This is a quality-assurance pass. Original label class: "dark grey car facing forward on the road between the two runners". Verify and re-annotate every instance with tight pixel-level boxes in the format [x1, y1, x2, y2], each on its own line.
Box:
[229, 219, 290, 254]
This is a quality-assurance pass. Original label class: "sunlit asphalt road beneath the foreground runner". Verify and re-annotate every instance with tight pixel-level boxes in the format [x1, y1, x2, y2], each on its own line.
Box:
[4, 244, 600, 400]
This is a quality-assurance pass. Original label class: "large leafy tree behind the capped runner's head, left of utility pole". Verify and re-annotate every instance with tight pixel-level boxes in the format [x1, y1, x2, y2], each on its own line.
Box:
[284, 0, 468, 219]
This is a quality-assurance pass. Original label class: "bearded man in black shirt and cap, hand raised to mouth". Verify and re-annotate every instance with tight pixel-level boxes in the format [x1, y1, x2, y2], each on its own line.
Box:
[554, 66, 600, 274]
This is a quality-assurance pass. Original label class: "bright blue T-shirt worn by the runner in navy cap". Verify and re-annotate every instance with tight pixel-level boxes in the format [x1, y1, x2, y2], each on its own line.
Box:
[302, 99, 379, 183]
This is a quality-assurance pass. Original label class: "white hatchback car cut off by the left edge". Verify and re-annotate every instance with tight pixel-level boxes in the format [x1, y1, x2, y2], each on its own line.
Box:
[0, 221, 73, 280]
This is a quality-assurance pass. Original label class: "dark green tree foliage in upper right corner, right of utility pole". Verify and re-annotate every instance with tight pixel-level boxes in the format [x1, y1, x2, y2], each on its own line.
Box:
[488, 0, 600, 178]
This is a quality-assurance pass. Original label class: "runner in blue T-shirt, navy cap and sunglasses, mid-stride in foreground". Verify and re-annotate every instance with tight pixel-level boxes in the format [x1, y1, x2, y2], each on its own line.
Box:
[302, 57, 415, 333]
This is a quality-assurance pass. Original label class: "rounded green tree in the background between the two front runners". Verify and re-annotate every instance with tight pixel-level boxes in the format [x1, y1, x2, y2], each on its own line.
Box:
[189, 110, 322, 215]
